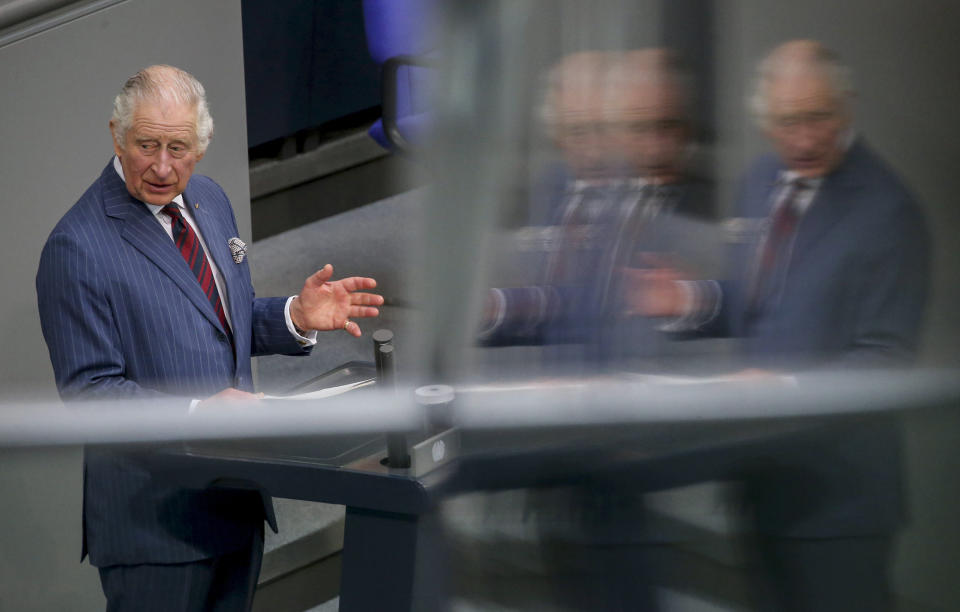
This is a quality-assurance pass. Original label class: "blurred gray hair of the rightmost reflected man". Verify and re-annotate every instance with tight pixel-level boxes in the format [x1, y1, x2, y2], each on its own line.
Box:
[747, 41, 856, 126]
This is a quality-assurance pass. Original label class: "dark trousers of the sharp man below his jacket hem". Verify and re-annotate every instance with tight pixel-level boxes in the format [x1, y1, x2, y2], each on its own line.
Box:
[100, 527, 263, 612]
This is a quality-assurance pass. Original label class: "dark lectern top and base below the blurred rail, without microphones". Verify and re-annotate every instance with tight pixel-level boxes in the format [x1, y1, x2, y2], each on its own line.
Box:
[151, 435, 452, 611]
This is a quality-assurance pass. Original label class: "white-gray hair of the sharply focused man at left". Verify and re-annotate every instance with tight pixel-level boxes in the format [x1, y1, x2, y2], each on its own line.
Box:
[111, 64, 213, 154]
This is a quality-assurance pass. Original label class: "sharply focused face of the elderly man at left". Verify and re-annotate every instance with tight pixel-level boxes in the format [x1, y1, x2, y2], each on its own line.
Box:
[110, 102, 203, 206]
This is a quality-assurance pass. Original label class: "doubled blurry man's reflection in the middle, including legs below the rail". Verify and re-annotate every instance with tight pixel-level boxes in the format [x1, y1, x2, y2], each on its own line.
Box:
[474, 49, 712, 609]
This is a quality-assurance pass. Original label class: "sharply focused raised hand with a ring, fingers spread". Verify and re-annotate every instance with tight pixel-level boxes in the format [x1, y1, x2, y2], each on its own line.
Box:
[290, 264, 383, 336]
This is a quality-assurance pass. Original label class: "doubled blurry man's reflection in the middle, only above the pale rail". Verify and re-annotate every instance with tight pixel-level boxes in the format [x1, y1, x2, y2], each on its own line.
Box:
[483, 49, 711, 368]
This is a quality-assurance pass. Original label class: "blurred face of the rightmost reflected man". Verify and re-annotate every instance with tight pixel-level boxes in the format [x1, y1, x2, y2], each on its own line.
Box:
[764, 72, 849, 178]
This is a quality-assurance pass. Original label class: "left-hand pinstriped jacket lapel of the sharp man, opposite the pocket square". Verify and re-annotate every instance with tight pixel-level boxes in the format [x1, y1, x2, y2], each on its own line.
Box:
[101, 163, 220, 327]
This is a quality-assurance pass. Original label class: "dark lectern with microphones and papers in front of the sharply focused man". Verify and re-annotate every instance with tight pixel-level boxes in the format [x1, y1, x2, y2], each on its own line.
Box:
[150, 330, 458, 611]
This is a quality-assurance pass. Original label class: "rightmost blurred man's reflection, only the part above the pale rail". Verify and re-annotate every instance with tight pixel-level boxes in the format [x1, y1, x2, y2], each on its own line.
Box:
[633, 41, 929, 370]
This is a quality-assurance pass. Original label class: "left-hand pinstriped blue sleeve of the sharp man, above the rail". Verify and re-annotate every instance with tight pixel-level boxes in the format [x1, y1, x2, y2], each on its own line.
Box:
[37, 232, 170, 400]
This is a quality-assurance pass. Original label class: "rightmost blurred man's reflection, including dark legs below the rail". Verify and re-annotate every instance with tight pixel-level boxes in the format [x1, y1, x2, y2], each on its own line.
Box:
[638, 41, 929, 610]
